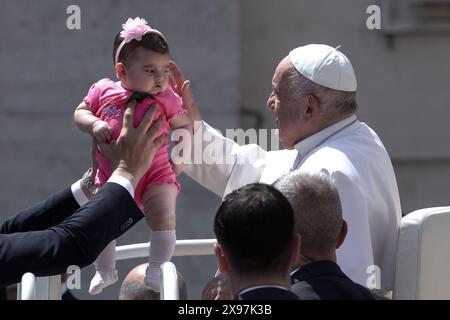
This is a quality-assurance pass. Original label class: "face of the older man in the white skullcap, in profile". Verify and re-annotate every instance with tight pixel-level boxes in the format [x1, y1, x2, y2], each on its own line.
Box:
[267, 57, 306, 149]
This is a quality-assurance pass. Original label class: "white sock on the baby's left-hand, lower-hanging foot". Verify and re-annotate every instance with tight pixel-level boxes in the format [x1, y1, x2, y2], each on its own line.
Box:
[89, 240, 118, 295]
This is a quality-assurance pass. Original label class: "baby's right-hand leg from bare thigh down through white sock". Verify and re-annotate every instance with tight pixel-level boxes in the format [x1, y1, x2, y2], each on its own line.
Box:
[142, 183, 178, 291]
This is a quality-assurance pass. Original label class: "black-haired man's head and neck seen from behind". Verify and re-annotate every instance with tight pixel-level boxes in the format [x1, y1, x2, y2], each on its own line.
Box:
[214, 183, 300, 294]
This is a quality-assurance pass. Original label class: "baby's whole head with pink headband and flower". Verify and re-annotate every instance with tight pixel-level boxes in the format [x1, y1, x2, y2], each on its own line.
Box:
[113, 17, 170, 95]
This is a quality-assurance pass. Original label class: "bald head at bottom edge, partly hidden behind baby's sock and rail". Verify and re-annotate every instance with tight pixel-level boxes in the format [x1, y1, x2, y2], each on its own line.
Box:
[119, 263, 187, 300]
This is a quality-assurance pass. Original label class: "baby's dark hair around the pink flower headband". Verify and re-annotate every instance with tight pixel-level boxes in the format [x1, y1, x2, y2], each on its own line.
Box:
[113, 32, 169, 65]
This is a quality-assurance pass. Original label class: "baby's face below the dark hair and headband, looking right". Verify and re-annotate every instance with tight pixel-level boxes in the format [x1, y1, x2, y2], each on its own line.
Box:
[124, 47, 170, 95]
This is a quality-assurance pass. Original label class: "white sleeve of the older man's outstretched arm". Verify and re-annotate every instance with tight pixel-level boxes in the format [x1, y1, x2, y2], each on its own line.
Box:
[184, 122, 266, 197]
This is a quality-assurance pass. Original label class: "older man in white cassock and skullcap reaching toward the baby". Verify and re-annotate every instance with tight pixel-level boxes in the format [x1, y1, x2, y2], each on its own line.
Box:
[172, 44, 401, 290]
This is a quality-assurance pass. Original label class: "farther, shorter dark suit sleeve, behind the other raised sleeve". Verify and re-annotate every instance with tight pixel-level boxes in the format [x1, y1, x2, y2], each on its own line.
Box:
[0, 187, 80, 233]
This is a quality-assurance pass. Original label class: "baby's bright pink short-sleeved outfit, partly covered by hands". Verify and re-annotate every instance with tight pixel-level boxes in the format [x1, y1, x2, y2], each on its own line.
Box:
[84, 78, 186, 208]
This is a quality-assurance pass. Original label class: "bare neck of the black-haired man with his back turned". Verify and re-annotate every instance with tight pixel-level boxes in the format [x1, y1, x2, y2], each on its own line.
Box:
[229, 273, 291, 296]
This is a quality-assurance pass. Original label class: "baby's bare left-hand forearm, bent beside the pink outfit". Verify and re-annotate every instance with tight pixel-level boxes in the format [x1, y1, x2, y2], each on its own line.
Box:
[73, 101, 112, 142]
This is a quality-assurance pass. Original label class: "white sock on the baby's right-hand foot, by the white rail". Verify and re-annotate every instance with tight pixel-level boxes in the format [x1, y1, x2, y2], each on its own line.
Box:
[144, 230, 177, 292]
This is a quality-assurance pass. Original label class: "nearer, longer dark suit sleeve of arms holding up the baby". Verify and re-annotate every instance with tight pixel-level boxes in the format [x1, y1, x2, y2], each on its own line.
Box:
[0, 183, 143, 287]
